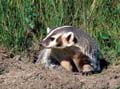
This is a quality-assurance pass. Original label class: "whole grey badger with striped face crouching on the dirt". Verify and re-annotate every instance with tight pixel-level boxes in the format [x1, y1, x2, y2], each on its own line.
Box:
[39, 26, 100, 73]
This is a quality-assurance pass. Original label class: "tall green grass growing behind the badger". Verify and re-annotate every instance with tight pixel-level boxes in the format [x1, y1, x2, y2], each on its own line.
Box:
[0, 0, 120, 63]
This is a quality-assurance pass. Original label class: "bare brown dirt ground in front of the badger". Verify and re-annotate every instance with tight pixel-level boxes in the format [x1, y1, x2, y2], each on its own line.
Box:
[0, 49, 120, 89]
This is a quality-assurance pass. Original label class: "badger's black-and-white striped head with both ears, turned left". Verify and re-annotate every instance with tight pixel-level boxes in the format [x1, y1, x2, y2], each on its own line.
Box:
[40, 27, 77, 48]
